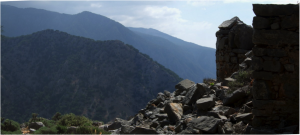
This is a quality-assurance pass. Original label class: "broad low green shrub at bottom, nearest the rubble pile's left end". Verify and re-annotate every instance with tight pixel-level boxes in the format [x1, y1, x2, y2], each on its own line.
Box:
[57, 113, 92, 126]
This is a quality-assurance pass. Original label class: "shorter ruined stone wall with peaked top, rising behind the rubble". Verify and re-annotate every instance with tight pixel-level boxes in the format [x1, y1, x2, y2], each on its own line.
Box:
[216, 17, 253, 82]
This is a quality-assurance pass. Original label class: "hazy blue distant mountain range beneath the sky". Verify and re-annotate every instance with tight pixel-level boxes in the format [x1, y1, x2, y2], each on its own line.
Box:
[0, 5, 216, 82]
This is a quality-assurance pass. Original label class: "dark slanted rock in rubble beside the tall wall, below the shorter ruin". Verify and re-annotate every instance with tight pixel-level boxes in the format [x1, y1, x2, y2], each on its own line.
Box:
[223, 86, 248, 105]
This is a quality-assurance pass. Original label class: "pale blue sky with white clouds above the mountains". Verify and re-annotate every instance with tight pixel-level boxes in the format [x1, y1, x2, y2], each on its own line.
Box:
[0, 0, 300, 48]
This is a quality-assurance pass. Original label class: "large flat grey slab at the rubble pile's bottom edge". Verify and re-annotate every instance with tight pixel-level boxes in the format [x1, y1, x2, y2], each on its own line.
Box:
[188, 116, 220, 133]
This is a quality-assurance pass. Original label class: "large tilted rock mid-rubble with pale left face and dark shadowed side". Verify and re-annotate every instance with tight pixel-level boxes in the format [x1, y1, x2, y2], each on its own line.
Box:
[182, 83, 207, 105]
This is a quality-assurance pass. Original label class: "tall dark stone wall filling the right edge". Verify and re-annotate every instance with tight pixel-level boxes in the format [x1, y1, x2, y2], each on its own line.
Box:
[252, 4, 300, 129]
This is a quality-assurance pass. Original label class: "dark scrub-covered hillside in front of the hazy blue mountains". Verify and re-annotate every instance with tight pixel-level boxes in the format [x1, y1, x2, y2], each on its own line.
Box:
[0, 30, 181, 122]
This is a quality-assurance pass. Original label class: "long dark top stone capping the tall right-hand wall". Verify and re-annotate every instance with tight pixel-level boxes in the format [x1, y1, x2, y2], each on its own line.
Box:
[253, 4, 296, 16]
